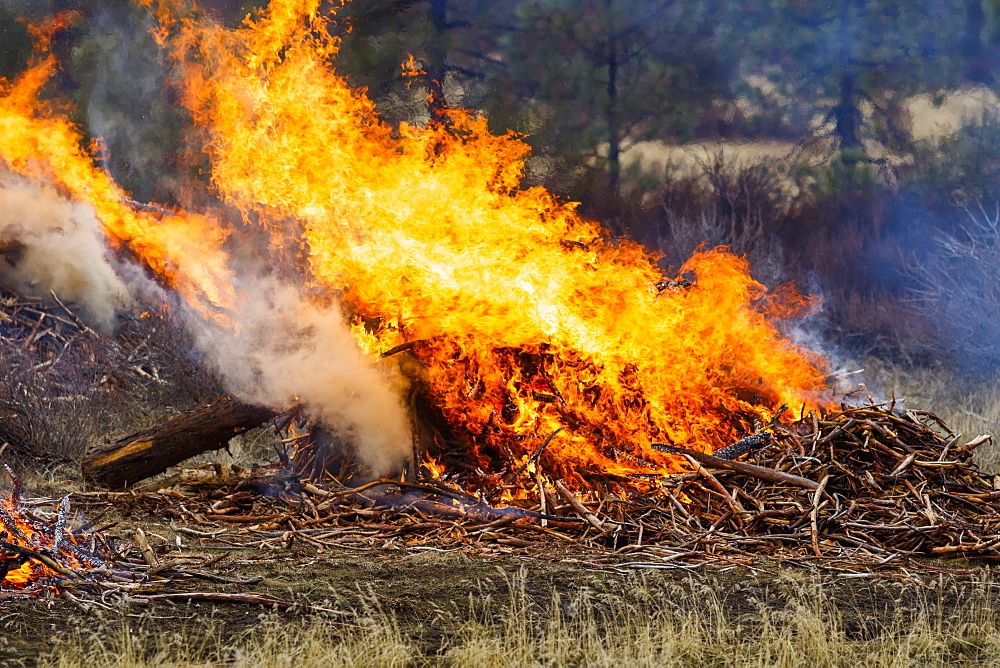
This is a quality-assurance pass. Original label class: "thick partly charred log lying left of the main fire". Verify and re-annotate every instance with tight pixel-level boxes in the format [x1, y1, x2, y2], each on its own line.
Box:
[82, 399, 277, 489]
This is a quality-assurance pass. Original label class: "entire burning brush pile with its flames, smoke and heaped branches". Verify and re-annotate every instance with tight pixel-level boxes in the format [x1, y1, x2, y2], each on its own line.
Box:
[0, 0, 1000, 580]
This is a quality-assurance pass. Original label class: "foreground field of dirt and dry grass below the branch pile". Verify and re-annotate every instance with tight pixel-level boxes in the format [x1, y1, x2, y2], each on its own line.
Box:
[27, 555, 1000, 668]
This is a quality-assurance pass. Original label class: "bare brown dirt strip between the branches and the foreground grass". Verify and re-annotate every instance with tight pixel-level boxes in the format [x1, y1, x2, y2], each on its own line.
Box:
[0, 500, 1000, 666]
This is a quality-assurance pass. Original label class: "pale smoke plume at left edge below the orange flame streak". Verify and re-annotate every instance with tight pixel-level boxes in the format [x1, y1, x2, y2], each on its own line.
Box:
[0, 172, 130, 331]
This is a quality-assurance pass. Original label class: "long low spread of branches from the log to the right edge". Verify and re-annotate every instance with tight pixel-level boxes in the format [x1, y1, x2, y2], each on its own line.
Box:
[82, 406, 1000, 575]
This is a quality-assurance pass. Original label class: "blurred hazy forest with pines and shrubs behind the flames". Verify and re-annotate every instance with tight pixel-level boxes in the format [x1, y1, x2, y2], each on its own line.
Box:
[0, 0, 1000, 402]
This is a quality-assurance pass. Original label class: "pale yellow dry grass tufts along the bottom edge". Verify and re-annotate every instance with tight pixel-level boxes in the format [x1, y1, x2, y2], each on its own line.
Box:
[39, 574, 1000, 668]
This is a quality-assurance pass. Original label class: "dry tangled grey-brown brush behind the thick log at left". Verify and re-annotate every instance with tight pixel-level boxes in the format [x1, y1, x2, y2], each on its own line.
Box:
[0, 293, 218, 468]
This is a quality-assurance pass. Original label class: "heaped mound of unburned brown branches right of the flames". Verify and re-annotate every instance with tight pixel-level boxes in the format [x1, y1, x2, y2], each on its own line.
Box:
[625, 406, 1000, 558]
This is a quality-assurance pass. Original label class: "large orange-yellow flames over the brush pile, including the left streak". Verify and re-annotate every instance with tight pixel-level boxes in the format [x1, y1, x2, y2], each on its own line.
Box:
[0, 0, 824, 486]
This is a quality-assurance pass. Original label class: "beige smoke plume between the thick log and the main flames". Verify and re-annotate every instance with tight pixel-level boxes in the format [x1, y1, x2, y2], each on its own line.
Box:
[182, 276, 412, 477]
